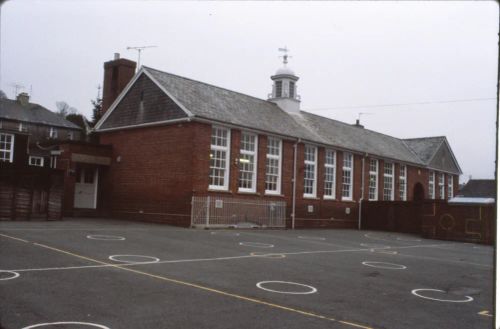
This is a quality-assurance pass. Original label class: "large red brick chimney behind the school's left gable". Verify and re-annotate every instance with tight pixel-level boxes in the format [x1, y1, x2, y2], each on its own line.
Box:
[101, 53, 137, 114]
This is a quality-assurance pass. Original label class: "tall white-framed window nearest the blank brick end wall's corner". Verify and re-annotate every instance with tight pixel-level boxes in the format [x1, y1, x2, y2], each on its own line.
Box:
[208, 127, 231, 190]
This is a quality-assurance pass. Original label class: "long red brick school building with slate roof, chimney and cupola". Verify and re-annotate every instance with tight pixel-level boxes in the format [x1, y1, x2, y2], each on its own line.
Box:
[95, 55, 461, 227]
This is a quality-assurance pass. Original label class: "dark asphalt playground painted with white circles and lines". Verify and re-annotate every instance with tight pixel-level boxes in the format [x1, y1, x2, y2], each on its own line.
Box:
[0, 219, 494, 329]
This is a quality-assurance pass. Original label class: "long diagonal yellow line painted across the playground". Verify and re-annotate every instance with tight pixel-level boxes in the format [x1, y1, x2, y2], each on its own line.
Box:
[26, 238, 374, 329]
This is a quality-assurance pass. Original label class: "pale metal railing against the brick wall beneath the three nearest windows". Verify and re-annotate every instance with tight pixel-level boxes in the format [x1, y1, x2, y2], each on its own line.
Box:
[191, 196, 286, 227]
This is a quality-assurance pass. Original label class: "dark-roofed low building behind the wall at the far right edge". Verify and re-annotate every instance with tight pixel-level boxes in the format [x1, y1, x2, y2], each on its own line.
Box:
[450, 179, 497, 204]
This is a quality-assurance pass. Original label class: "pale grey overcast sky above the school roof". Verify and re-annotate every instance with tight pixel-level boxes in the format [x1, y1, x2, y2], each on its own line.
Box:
[0, 0, 499, 181]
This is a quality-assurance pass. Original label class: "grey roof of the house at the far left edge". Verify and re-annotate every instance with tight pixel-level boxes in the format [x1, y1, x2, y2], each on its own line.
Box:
[0, 98, 81, 130]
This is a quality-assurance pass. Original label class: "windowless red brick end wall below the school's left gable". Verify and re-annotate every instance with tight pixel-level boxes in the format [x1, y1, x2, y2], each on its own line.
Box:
[101, 123, 197, 226]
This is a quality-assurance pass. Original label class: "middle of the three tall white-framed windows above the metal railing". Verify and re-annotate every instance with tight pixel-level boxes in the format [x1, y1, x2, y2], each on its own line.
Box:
[238, 132, 258, 192]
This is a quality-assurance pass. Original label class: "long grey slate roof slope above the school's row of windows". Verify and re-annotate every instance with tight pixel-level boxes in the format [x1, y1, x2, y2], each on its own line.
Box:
[97, 66, 460, 169]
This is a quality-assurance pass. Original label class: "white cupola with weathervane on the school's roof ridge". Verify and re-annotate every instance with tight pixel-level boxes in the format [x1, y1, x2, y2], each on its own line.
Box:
[268, 47, 300, 113]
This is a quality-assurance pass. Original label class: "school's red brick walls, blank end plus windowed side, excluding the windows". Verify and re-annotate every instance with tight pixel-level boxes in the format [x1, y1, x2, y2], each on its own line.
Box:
[96, 122, 460, 228]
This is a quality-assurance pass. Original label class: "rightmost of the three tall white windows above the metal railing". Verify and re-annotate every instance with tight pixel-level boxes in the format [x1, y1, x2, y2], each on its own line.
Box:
[266, 137, 282, 194]
